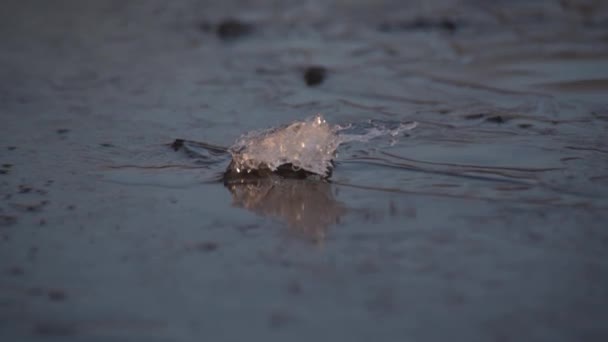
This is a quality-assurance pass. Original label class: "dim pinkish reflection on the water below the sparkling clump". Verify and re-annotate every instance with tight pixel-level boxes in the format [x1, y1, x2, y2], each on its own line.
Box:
[226, 176, 346, 241]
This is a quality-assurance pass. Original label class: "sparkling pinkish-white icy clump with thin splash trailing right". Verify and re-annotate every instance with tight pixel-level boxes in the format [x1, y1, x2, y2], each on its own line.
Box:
[229, 114, 416, 176]
